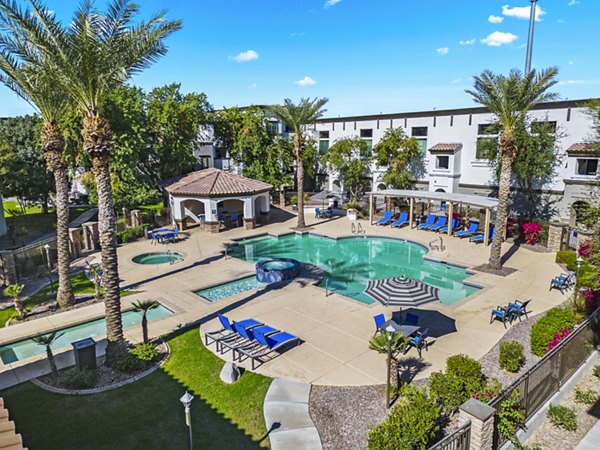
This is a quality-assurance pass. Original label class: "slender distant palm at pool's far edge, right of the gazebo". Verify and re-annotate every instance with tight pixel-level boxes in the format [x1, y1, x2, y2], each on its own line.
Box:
[269, 98, 328, 229]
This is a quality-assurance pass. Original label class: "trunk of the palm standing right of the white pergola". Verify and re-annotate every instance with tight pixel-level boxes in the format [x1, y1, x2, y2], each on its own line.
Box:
[489, 138, 515, 270]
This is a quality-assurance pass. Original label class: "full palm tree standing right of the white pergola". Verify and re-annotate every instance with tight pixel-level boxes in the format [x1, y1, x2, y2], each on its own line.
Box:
[466, 67, 558, 269]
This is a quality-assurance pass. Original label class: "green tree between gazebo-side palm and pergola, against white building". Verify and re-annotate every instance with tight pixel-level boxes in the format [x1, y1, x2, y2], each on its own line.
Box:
[322, 137, 371, 202]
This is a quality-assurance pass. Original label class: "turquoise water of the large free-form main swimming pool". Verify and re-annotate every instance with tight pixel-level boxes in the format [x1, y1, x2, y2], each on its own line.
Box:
[230, 233, 479, 305]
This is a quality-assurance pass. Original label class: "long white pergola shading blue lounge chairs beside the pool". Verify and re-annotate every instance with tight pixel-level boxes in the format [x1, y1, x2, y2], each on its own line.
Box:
[368, 189, 498, 245]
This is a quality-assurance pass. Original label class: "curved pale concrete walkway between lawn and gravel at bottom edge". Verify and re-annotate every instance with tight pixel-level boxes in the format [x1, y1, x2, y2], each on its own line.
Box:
[264, 379, 323, 450]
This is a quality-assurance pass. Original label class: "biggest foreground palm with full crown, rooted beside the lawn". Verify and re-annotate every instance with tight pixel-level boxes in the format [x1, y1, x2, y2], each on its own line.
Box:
[0, 0, 181, 366]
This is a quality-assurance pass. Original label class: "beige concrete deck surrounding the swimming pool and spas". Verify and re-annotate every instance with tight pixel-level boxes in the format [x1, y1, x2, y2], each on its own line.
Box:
[0, 210, 567, 387]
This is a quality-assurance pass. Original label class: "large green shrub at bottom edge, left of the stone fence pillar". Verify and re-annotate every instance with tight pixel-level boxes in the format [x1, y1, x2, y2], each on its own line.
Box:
[368, 386, 440, 450]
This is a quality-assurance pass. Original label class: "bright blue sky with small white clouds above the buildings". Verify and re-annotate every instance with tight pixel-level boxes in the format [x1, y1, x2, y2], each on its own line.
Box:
[0, 0, 600, 116]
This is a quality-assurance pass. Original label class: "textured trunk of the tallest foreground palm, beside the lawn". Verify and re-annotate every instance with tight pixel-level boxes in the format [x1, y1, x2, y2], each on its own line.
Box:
[81, 115, 126, 366]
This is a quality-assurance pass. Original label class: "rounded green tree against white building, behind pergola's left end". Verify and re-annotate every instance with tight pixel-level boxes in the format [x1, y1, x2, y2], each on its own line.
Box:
[373, 128, 423, 189]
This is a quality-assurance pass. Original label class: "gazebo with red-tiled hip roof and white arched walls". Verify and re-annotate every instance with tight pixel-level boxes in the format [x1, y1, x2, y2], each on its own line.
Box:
[162, 168, 273, 233]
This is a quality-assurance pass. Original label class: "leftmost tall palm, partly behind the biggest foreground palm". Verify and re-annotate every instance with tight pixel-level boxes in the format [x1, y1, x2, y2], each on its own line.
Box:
[0, 54, 75, 308]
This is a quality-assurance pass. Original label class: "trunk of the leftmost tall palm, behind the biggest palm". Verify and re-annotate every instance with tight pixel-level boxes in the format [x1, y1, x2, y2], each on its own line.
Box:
[41, 122, 75, 308]
